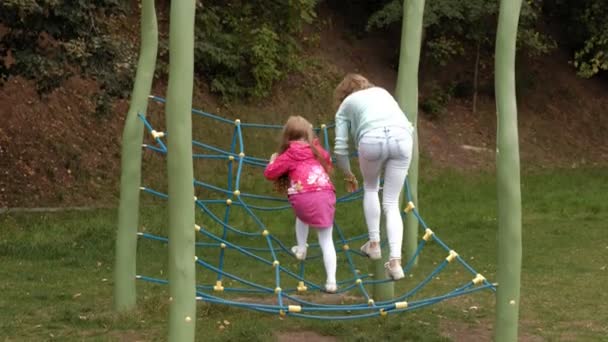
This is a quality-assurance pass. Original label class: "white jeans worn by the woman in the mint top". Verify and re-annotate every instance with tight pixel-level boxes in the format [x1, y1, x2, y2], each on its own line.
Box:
[358, 127, 413, 259]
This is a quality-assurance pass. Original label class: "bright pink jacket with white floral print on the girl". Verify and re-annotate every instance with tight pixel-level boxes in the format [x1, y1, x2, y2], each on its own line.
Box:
[264, 140, 335, 195]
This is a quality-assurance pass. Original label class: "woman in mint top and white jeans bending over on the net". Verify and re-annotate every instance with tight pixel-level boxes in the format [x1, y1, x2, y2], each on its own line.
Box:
[334, 74, 413, 280]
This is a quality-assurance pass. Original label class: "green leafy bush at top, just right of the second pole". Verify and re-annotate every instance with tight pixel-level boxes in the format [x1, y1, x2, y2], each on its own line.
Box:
[195, 0, 318, 98]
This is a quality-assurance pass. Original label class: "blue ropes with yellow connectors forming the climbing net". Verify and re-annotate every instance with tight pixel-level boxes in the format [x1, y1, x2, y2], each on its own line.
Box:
[138, 96, 496, 320]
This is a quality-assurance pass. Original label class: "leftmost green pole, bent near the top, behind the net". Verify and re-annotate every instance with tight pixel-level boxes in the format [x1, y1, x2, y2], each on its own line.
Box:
[114, 0, 158, 311]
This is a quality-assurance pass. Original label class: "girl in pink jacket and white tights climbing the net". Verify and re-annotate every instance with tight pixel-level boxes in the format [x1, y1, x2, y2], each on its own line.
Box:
[264, 116, 337, 293]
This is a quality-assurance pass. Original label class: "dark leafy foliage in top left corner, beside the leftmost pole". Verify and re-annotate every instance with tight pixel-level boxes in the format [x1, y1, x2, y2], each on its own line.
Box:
[0, 0, 134, 113]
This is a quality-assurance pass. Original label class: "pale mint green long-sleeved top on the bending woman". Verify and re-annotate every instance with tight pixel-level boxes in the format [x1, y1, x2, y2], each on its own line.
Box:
[334, 87, 412, 162]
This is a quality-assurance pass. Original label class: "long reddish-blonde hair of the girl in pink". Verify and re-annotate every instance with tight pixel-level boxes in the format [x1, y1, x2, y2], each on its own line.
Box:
[275, 115, 331, 193]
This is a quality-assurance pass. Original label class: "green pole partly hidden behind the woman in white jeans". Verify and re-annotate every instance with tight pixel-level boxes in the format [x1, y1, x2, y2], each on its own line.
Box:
[395, 0, 424, 260]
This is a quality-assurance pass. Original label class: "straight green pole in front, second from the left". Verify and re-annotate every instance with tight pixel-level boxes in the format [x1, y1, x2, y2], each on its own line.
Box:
[165, 0, 196, 342]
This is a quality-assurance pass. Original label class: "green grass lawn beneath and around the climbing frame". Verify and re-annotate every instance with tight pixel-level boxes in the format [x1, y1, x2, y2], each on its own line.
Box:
[0, 169, 608, 341]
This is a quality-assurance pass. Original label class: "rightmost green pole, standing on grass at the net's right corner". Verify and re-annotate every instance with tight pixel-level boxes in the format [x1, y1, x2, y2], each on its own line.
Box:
[495, 0, 522, 342]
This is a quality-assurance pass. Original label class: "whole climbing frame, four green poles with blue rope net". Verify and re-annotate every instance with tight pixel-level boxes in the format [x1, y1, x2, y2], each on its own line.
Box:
[115, 0, 521, 341]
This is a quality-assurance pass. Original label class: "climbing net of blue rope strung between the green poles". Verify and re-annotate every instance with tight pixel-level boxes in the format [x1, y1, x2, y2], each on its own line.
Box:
[137, 96, 496, 320]
